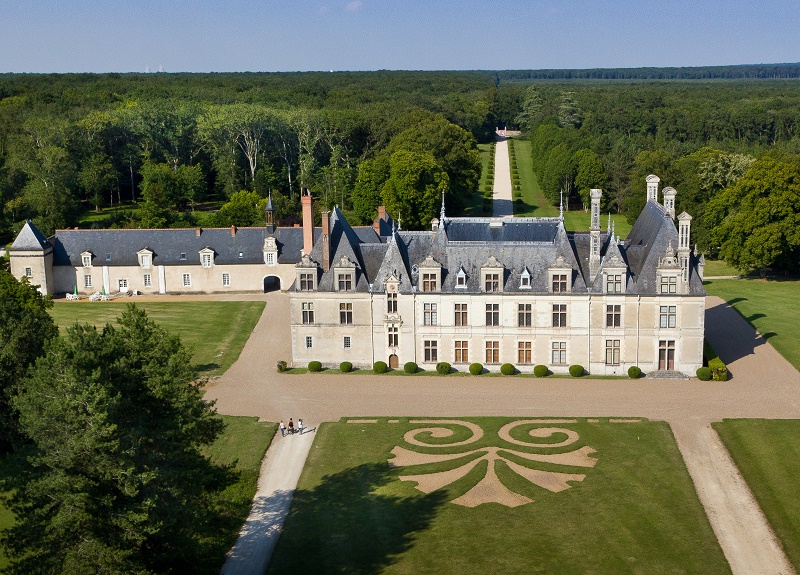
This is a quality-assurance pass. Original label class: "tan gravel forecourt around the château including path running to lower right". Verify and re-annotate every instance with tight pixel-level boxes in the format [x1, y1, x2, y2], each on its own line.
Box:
[206, 294, 800, 575]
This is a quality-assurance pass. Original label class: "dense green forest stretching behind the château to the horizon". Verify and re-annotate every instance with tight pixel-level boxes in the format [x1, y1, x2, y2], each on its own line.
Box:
[0, 65, 800, 271]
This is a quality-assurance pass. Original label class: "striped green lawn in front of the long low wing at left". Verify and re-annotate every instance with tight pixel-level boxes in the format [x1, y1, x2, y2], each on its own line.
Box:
[50, 301, 265, 377]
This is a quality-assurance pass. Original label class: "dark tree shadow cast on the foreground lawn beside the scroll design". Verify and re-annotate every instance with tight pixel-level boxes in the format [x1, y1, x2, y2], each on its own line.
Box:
[267, 463, 446, 575]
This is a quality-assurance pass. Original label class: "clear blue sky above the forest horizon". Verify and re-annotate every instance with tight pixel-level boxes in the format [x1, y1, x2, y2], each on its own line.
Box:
[0, 0, 800, 72]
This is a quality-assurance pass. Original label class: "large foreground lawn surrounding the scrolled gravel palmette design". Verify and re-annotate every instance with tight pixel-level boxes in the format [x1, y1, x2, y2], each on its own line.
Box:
[267, 418, 730, 575]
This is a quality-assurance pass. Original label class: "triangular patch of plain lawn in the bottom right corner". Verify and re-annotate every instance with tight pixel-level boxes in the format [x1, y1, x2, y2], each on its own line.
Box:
[712, 419, 800, 571]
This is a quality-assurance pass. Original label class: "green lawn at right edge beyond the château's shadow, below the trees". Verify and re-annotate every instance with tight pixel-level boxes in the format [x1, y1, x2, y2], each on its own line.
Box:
[703, 279, 800, 369]
